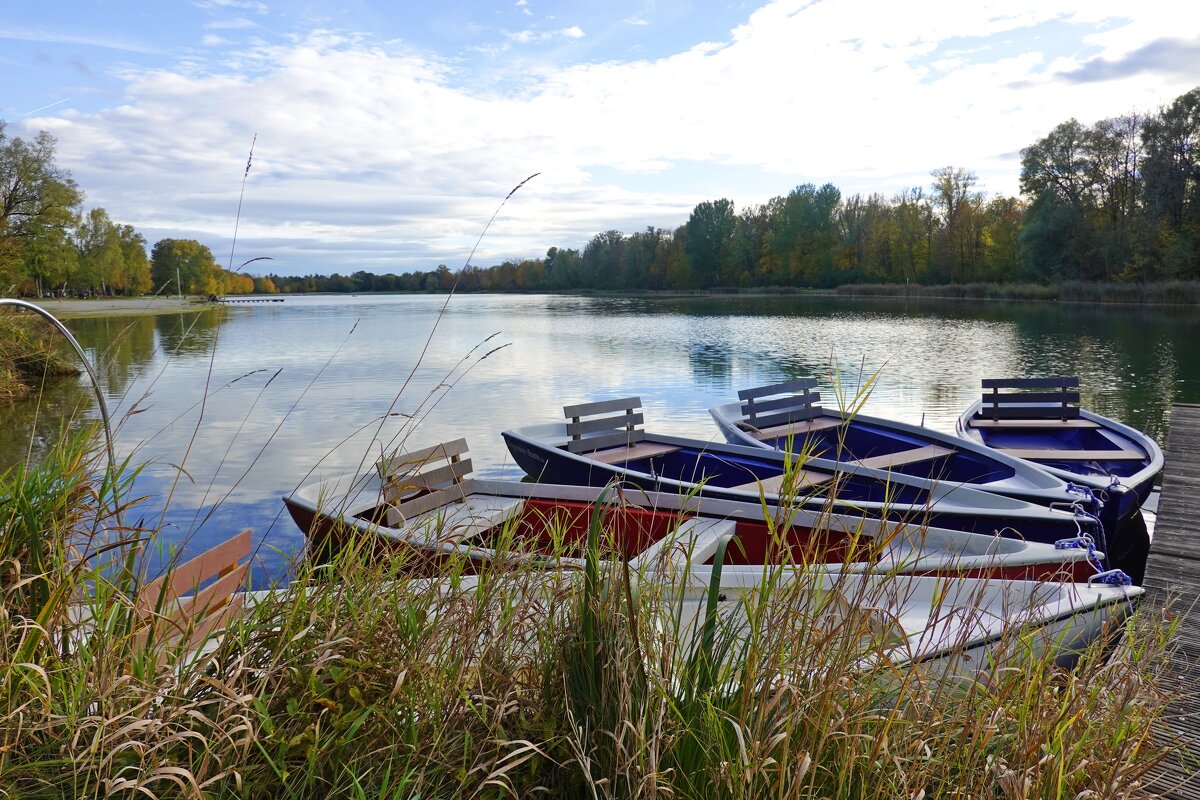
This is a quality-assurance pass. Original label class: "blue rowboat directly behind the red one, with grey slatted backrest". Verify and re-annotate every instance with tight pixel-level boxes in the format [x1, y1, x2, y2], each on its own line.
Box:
[503, 397, 1103, 549]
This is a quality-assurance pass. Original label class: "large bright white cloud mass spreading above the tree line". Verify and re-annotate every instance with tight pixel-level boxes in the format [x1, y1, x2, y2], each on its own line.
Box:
[36, 0, 1200, 272]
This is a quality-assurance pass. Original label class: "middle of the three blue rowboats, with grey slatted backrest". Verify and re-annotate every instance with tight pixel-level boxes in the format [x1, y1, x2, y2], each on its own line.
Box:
[709, 378, 1099, 513]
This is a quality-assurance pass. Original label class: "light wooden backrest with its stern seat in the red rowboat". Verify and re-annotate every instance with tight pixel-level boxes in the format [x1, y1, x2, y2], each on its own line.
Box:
[378, 439, 524, 543]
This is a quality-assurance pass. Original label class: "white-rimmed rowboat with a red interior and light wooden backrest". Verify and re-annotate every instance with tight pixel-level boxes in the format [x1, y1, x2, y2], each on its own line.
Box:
[284, 439, 1102, 587]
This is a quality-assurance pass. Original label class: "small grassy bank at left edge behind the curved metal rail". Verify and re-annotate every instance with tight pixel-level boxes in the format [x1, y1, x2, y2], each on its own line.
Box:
[0, 309, 79, 408]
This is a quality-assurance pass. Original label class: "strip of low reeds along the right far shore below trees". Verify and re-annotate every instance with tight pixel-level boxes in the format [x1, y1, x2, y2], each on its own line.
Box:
[838, 281, 1200, 306]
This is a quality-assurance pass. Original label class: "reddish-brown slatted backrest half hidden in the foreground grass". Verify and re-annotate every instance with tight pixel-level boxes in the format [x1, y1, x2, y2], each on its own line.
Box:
[134, 528, 251, 657]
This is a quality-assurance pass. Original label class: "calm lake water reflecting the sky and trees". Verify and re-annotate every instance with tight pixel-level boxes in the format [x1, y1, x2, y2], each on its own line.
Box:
[0, 295, 1200, 583]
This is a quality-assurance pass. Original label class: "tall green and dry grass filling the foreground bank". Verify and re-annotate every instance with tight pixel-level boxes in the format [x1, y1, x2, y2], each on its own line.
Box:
[0, 439, 1169, 800]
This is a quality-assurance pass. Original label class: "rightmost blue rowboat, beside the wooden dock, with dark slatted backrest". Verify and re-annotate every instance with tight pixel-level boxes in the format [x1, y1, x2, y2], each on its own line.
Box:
[956, 377, 1163, 582]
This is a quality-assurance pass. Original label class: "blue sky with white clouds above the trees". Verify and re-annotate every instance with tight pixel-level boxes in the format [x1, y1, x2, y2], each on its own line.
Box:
[0, 0, 1200, 275]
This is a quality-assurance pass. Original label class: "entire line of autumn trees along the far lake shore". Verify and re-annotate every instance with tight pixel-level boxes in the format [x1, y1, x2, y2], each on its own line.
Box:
[0, 88, 1200, 294]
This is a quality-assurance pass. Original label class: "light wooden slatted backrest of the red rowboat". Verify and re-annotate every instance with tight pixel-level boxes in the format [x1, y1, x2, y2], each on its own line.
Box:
[378, 439, 475, 525]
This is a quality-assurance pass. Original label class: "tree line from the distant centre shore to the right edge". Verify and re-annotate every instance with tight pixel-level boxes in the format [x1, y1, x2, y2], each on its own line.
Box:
[271, 88, 1200, 297]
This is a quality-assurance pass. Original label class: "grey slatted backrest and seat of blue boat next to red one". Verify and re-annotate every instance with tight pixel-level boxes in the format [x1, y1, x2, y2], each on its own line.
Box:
[563, 397, 678, 464]
